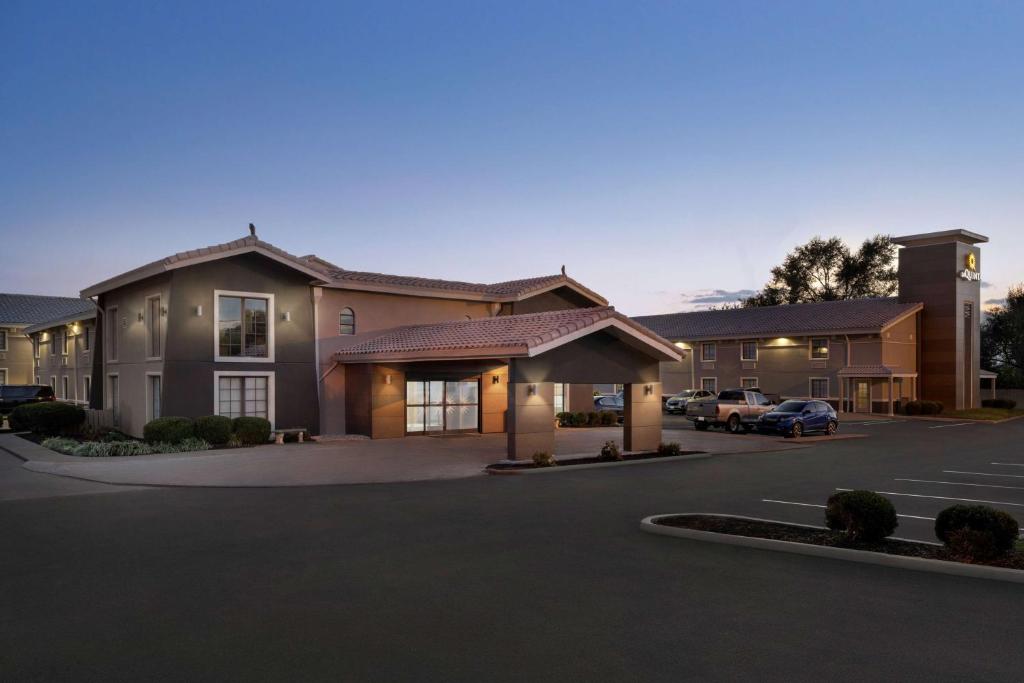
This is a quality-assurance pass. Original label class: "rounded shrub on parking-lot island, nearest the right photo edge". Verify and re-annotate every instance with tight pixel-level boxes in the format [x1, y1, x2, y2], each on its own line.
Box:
[935, 505, 1020, 561]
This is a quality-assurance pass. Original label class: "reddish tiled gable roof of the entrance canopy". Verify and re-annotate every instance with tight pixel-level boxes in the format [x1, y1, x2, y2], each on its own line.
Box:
[334, 306, 680, 362]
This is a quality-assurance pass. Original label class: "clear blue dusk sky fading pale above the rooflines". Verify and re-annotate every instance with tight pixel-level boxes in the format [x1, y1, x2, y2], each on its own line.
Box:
[0, 0, 1024, 315]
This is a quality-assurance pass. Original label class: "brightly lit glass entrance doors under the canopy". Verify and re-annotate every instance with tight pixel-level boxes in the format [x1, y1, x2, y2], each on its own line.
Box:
[406, 380, 480, 433]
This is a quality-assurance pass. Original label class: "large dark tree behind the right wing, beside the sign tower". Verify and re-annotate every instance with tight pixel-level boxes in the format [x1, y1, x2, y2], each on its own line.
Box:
[743, 234, 897, 307]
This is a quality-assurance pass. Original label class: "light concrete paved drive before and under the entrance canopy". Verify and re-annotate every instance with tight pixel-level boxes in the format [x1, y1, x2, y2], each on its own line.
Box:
[18, 427, 815, 486]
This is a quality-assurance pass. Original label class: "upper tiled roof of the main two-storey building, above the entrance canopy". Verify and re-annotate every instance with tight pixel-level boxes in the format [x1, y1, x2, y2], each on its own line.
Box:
[82, 236, 608, 304]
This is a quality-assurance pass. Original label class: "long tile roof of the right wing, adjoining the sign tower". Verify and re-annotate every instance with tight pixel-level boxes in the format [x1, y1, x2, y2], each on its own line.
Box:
[633, 298, 922, 341]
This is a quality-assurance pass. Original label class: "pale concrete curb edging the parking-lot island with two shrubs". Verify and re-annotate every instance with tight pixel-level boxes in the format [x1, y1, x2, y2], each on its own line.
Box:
[640, 512, 1024, 584]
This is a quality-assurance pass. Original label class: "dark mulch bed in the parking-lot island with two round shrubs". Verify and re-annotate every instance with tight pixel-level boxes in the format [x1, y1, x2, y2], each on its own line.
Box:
[656, 515, 1024, 569]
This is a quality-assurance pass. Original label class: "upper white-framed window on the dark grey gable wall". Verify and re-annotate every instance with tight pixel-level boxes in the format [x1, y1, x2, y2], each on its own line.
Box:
[213, 290, 273, 362]
